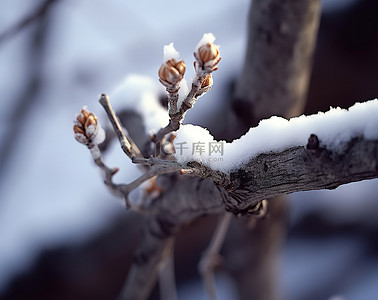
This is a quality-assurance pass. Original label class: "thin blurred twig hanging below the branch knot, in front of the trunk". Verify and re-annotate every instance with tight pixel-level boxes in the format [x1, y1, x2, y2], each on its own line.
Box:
[198, 212, 232, 300]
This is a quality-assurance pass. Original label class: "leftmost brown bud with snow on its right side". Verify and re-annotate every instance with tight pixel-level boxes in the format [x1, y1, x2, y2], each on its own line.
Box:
[73, 108, 105, 146]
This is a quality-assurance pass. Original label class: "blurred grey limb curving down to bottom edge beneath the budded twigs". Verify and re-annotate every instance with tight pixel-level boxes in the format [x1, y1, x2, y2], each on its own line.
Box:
[119, 175, 227, 300]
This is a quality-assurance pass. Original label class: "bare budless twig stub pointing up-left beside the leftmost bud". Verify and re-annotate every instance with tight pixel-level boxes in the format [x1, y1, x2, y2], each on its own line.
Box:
[99, 94, 142, 160]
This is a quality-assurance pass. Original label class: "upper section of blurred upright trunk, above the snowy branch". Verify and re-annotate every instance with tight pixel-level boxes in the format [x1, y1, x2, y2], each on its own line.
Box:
[234, 0, 320, 128]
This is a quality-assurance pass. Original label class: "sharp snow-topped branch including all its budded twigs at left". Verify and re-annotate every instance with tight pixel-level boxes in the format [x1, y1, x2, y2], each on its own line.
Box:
[74, 34, 378, 214]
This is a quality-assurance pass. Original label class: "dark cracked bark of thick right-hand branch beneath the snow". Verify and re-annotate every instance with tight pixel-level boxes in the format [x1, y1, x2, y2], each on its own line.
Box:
[226, 136, 378, 213]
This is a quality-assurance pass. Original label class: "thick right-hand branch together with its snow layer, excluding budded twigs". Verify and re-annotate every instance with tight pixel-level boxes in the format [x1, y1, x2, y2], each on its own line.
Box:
[175, 99, 378, 214]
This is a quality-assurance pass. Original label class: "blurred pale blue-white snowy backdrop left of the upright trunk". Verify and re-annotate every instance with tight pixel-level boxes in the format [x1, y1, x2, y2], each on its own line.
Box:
[0, 0, 376, 293]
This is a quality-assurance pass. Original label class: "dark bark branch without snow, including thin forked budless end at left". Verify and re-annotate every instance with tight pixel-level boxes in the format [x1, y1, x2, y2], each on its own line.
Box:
[103, 93, 378, 214]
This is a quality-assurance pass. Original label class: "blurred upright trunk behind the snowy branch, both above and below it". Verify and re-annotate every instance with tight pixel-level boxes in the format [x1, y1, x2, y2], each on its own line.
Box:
[226, 0, 320, 300]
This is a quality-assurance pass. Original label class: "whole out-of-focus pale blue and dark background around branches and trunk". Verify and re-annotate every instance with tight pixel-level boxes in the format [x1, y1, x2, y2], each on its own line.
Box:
[0, 0, 378, 300]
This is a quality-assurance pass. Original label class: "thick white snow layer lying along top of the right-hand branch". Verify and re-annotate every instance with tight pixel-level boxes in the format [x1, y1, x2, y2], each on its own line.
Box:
[174, 99, 378, 172]
